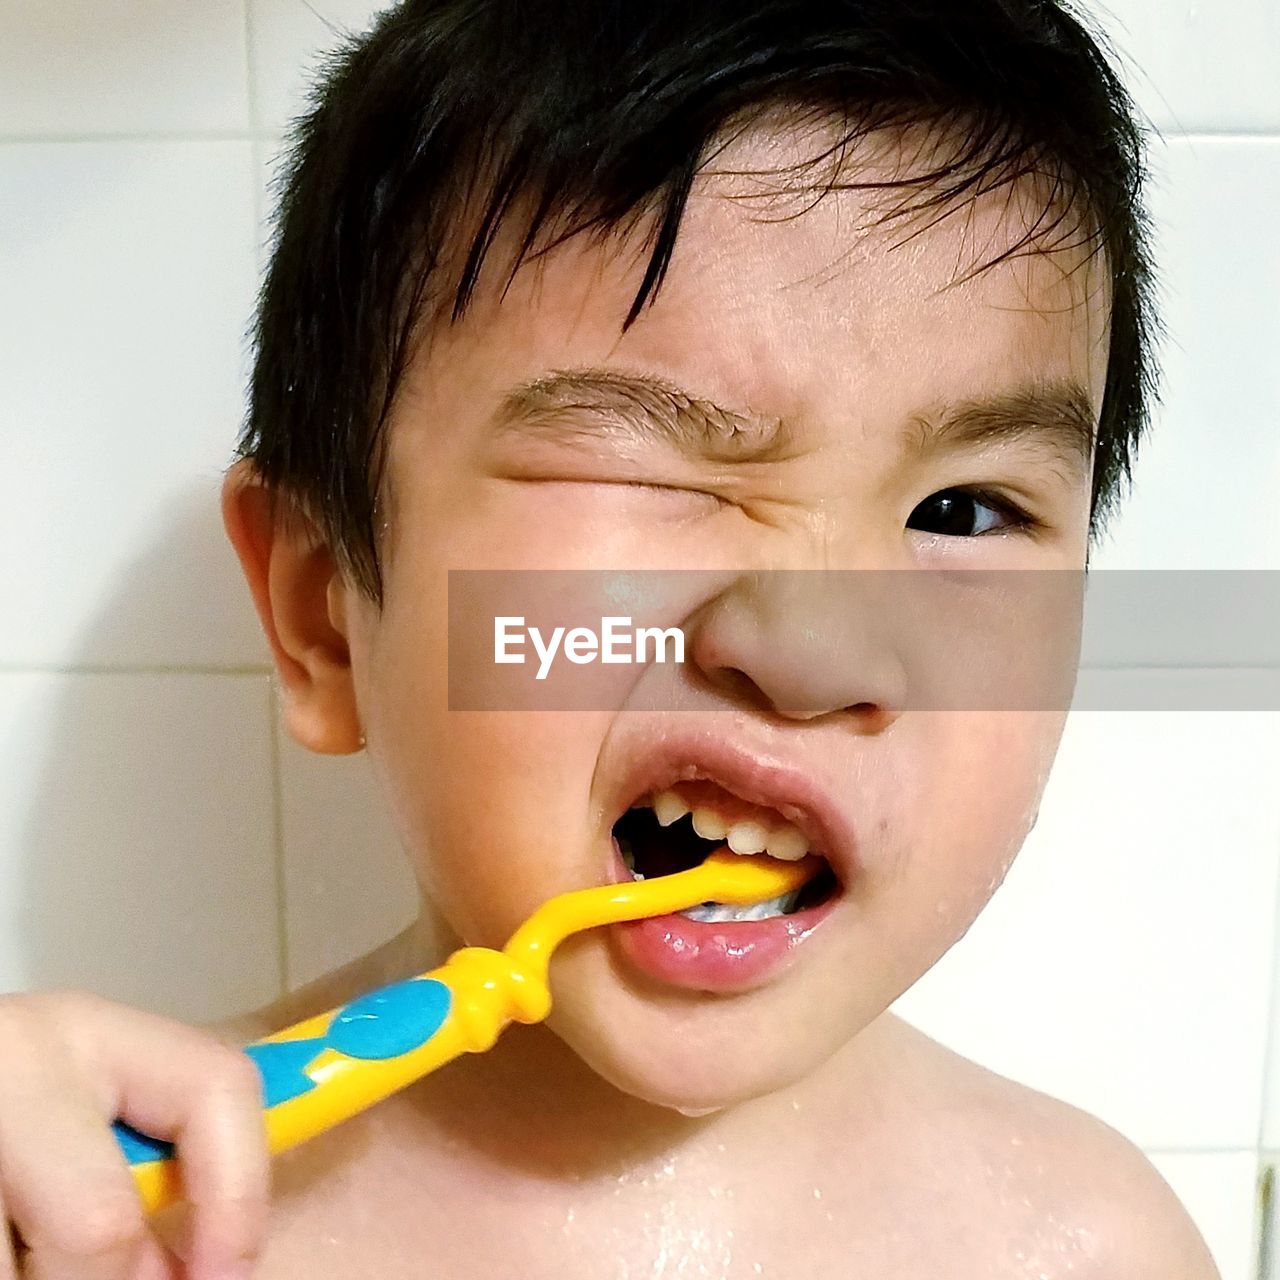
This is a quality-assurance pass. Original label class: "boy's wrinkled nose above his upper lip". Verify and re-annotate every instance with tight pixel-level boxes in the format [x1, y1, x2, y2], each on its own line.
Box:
[689, 570, 908, 733]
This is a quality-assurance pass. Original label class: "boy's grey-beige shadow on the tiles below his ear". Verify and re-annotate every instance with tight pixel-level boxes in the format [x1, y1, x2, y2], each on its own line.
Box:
[10, 475, 417, 1021]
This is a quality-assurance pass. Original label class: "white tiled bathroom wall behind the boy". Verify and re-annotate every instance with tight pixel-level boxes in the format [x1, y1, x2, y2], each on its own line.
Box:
[0, 0, 1280, 1280]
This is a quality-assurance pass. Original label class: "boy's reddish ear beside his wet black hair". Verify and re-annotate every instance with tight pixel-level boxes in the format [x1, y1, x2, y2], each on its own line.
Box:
[221, 458, 365, 755]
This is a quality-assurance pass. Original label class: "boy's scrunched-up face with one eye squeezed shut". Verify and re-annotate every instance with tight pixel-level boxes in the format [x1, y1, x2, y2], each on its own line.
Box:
[247, 124, 1107, 1107]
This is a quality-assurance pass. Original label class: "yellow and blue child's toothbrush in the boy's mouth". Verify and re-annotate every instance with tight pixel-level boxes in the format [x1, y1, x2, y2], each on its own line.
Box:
[111, 849, 817, 1212]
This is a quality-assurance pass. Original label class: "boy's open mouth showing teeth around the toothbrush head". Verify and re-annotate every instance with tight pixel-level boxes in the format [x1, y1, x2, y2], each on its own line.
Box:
[613, 780, 840, 923]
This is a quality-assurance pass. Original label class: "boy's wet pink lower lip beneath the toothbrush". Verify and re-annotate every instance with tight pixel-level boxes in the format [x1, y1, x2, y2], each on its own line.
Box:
[608, 844, 838, 993]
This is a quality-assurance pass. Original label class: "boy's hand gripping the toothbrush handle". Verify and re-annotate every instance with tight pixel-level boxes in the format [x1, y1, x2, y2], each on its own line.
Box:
[0, 991, 270, 1280]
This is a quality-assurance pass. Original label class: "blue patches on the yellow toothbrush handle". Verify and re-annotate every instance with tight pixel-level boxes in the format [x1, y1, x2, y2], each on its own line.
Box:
[111, 978, 452, 1165]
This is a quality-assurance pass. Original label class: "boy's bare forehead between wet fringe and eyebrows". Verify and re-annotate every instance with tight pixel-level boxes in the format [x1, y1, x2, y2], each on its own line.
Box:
[397, 120, 1108, 460]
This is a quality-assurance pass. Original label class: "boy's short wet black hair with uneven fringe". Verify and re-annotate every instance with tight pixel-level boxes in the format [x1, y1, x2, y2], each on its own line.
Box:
[236, 0, 1158, 605]
